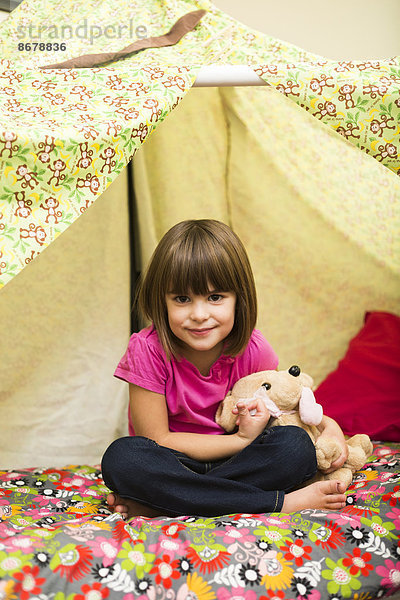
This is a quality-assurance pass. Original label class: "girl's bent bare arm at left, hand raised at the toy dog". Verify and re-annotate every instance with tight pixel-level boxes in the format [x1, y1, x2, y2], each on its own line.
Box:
[129, 383, 269, 461]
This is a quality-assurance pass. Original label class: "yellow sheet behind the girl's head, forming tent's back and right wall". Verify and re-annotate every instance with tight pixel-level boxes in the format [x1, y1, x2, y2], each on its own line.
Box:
[134, 88, 400, 383]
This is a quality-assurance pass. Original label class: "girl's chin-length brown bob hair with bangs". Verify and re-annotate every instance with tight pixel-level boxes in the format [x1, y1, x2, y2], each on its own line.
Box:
[137, 219, 257, 358]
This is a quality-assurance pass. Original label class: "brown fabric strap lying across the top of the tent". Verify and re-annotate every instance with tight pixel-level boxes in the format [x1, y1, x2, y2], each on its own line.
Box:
[40, 10, 207, 69]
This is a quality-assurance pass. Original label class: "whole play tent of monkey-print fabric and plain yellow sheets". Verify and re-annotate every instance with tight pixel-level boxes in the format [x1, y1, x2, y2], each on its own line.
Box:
[0, 0, 400, 468]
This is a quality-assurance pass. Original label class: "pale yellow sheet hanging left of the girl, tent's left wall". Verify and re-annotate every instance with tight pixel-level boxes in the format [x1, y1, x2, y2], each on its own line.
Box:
[0, 172, 130, 469]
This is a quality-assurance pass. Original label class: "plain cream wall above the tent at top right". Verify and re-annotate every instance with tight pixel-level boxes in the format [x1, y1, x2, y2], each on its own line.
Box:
[213, 0, 400, 60]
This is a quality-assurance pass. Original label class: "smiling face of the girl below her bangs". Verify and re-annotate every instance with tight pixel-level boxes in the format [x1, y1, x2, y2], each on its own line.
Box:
[166, 290, 236, 359]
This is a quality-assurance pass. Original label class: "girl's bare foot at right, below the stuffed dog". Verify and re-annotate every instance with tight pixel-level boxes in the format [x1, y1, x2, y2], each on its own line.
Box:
[282, 479, 346, 512]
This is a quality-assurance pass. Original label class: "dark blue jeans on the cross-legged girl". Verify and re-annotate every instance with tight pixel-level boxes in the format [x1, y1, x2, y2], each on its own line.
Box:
[101, 425, 317, 516]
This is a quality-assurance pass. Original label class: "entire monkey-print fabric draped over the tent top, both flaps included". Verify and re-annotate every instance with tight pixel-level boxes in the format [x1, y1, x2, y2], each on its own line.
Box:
[0, 0, 400, 287]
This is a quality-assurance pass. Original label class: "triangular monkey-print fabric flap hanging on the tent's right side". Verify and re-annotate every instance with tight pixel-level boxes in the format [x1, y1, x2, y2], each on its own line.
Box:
[255, 58, 400, 175]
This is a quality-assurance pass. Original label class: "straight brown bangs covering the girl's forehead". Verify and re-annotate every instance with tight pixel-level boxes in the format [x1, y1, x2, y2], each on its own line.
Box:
[165, 230, 239, 295]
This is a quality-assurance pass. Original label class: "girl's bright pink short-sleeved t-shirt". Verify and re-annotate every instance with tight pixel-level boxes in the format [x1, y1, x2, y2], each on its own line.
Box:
[114, 326, 278, 435]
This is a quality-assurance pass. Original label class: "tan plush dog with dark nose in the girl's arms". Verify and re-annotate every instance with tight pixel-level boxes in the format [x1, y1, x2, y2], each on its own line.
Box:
[215, 366, 372, 487]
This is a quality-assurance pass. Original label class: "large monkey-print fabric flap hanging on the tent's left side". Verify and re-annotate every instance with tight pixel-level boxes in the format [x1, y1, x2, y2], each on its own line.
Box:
[0, 59, 195, 287]
